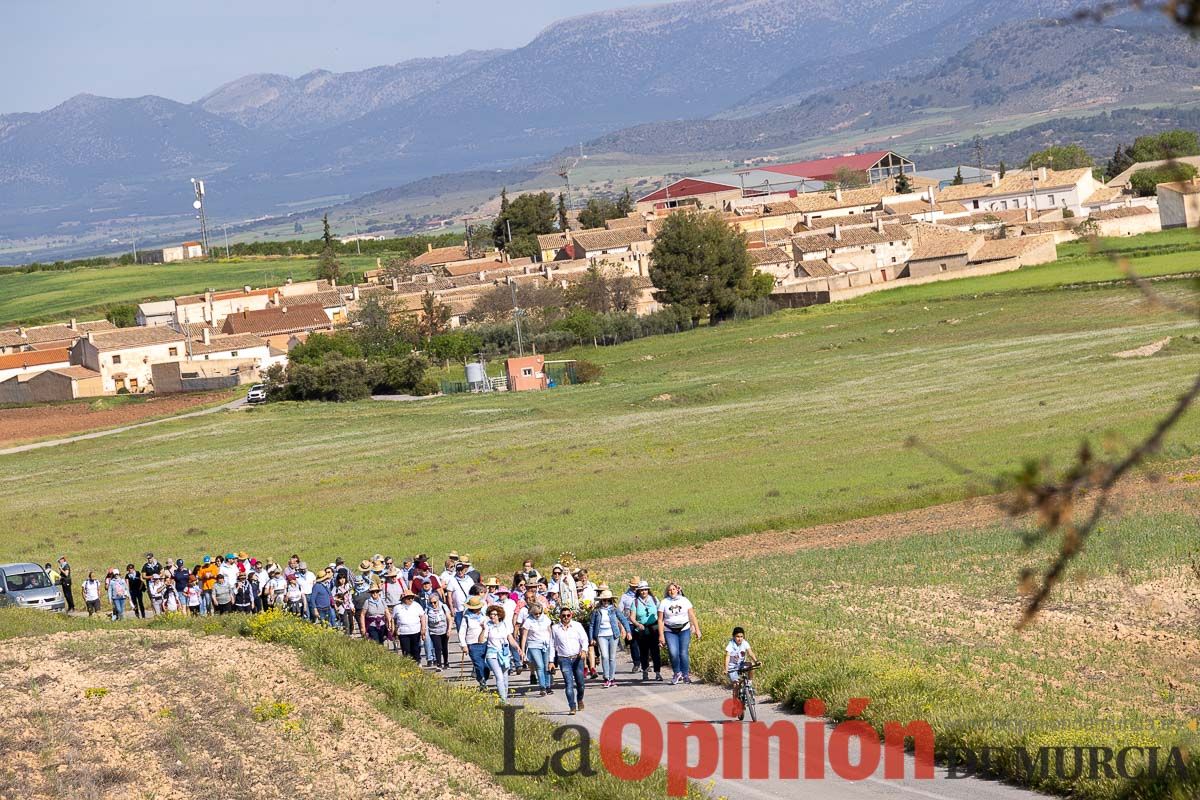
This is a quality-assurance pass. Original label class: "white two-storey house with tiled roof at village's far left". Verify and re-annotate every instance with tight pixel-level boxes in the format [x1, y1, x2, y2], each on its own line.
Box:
[71, 325, 187, 395]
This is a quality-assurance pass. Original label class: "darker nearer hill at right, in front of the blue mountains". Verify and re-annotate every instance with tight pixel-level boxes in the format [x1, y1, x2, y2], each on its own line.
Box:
[588, 20, 1200, 155]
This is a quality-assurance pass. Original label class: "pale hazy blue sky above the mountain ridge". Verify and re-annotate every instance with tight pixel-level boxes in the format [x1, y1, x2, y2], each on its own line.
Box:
[0, 0, 664, 113]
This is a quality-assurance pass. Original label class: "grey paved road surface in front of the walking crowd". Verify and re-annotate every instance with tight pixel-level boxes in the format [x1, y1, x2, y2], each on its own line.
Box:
[443, 642, 1044, 800]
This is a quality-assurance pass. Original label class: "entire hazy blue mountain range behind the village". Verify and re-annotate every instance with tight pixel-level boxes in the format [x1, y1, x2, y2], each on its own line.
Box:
[0, 0, 1180, 260]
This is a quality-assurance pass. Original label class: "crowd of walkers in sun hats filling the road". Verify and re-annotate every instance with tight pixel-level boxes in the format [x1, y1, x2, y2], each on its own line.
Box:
[46, 552, 701, 714]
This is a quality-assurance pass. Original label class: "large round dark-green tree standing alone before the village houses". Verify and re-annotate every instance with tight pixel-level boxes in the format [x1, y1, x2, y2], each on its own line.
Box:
[650, 211, 751, 324]
